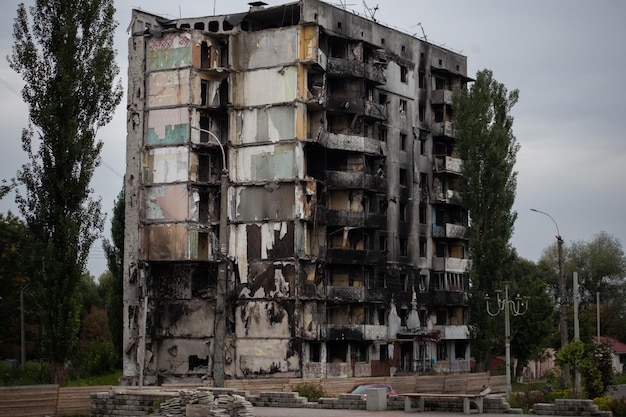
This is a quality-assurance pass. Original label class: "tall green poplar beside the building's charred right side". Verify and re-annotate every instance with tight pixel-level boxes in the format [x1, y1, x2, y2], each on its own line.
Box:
[453, 70, 519, 368]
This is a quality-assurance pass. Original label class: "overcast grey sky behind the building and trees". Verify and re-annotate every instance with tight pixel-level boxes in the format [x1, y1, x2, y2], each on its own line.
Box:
[0, 0, 626, 277]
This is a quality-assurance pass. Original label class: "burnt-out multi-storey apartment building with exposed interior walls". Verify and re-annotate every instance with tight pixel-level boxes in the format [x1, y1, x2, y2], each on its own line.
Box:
[123, 0, 470, 386]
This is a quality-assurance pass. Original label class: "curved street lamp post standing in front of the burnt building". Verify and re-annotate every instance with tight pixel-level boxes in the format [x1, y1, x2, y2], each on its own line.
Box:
[193, 127, 228, 387]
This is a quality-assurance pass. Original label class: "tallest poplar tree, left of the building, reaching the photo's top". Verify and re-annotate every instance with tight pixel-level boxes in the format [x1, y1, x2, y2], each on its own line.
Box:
[9, 0, 122, 385]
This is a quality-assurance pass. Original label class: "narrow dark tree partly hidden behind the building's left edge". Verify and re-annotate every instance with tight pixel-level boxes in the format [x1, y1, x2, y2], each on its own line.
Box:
[100, 188, 125, 356]
